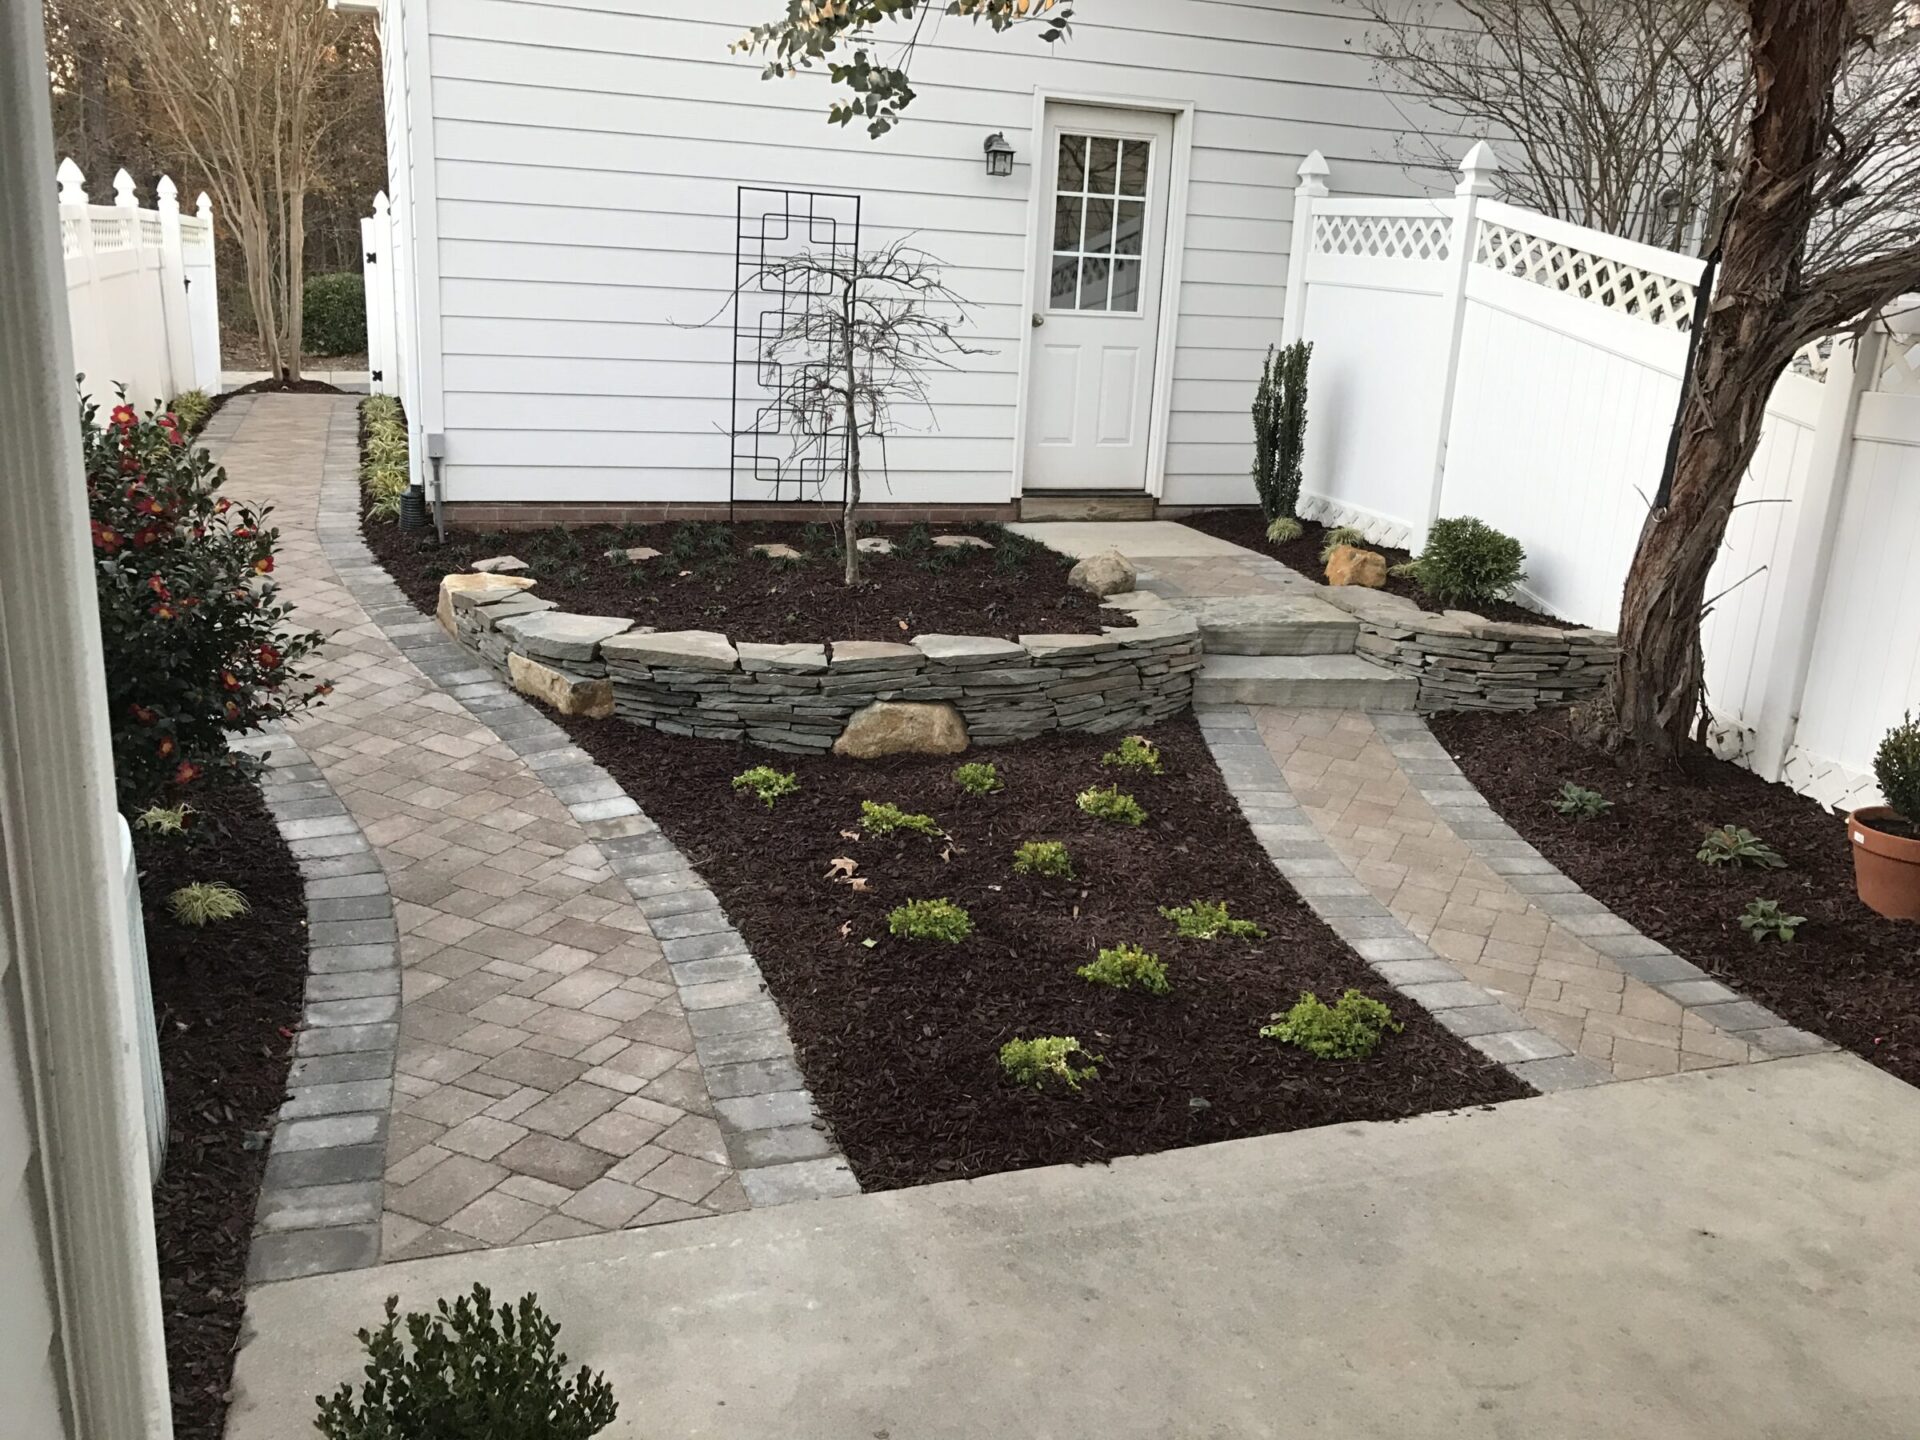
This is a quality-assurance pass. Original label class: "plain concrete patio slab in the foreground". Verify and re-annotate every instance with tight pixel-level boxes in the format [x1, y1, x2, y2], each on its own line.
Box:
[228, 1054, 1920, 1440]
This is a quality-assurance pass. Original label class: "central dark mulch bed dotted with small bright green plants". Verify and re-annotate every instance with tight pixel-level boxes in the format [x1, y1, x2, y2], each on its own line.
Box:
[563, 718, 1524, 1190]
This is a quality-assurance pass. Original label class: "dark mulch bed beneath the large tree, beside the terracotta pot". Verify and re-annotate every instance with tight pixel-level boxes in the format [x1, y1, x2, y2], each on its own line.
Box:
[1432, 710, 1920, 1085]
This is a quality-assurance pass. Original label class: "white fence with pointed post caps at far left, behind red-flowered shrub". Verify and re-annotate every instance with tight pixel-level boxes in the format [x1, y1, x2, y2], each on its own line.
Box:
[58, 159, 221, 409]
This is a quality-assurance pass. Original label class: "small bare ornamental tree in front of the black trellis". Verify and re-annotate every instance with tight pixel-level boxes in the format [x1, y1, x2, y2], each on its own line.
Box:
[739, 240, 985, 586]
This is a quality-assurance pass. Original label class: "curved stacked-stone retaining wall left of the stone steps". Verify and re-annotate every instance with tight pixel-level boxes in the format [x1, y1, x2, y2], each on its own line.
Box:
[442, 588, 1200, 753]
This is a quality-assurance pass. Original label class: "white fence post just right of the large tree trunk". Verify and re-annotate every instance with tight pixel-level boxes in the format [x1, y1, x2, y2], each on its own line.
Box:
[1749, 326, 1885, 780]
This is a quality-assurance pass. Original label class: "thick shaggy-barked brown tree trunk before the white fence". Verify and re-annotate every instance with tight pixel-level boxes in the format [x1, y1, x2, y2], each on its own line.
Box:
[1597, 0, 1853, 764]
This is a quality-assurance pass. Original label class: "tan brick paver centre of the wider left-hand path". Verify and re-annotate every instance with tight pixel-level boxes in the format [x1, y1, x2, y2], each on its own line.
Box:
[213, 396, 747, 1260]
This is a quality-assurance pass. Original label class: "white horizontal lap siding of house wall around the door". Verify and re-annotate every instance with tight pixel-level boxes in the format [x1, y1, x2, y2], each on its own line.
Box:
[408, 0, 1451, 505]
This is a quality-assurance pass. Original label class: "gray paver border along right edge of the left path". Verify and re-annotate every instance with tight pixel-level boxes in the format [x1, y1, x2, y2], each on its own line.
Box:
[317, 399, 860, 1208]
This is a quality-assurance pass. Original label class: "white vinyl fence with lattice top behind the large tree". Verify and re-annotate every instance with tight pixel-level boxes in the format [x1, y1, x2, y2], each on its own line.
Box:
[1284, 144, 1920, 817]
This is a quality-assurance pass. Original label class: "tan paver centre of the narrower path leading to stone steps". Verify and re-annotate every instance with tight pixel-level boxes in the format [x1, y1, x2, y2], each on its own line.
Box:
[1252, 707, 1768, 1079]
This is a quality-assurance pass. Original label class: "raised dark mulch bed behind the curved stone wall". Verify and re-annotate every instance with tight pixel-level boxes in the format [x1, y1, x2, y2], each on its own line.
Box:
[361, 520, 1131, 643]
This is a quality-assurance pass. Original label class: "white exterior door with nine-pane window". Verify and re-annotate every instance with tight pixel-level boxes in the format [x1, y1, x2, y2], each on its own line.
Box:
[1021, 104, 1173, 490]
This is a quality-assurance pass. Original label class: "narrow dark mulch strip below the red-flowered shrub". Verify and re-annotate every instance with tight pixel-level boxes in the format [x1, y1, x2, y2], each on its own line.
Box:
[134, 780, 307, 1440]
